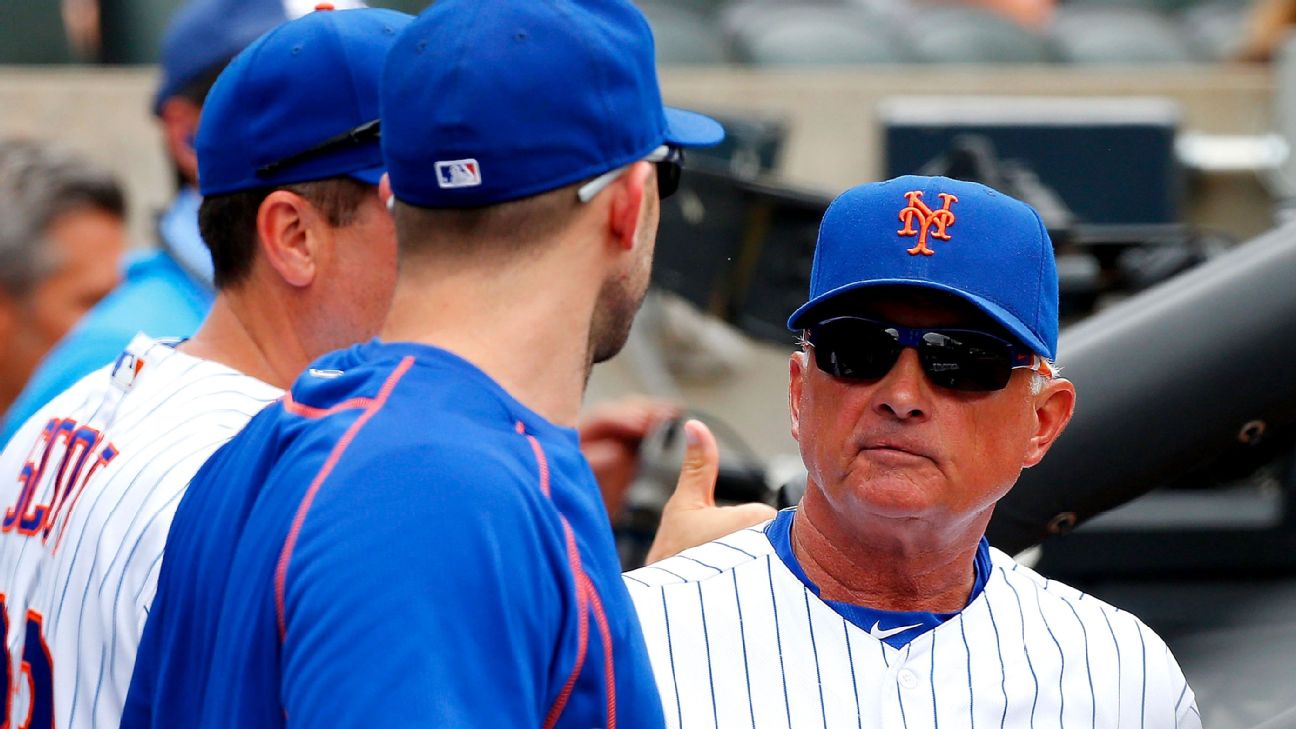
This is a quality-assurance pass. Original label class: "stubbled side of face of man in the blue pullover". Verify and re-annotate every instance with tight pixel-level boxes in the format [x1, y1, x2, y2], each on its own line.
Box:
[590, 170, 661, 365]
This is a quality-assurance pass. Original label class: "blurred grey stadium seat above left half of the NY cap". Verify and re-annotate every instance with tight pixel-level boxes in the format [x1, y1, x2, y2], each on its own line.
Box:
[722, 4, 914, 66]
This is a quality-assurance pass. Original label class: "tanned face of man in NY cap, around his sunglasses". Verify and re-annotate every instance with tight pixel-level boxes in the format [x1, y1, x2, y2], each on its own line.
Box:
[791, 288, 1052, 531]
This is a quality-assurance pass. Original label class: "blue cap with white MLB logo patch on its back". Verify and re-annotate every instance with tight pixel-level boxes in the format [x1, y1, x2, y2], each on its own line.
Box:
[382, 0, 724, 208]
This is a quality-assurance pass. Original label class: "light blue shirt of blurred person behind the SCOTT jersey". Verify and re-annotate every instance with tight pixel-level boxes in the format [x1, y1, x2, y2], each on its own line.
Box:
[0, 189, 215, 448]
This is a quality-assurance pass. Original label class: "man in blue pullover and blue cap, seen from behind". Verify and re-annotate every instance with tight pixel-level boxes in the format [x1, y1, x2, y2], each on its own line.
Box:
[127, 0, 722, 728]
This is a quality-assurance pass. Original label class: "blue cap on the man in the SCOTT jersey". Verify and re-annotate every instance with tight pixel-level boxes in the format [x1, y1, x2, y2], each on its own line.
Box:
[194, 9, 413, 195]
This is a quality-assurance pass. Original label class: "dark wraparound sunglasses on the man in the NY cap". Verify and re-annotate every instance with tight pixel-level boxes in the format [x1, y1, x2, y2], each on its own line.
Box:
[809, 317, 1052, 392]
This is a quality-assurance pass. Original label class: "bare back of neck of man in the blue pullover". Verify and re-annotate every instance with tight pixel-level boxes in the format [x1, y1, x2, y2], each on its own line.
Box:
[382, 257, 596, 427]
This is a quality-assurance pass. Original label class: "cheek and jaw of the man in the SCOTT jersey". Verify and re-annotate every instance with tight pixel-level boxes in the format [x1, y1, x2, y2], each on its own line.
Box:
[318, 188, 397, 353]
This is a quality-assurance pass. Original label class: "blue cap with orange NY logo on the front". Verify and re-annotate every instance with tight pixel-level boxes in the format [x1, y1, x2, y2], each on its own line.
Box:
[788, 175, 1058, 359]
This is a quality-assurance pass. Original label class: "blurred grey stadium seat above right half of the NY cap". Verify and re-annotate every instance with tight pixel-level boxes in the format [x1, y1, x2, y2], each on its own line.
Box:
[905, 5, 1054, 64]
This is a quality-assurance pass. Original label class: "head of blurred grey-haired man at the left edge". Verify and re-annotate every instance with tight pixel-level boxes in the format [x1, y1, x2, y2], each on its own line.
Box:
[0, 140, 126, 411]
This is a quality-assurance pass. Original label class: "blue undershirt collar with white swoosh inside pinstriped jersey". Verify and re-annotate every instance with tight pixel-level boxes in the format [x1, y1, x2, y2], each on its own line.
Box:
[765, 508, 990, 649]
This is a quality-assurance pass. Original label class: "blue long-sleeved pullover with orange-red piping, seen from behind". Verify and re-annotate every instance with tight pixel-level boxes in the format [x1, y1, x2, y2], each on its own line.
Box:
[122, 341, 664, 728]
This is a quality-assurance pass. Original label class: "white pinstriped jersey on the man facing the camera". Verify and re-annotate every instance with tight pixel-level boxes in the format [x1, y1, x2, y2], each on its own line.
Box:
[625, 511, 1201, 729]
